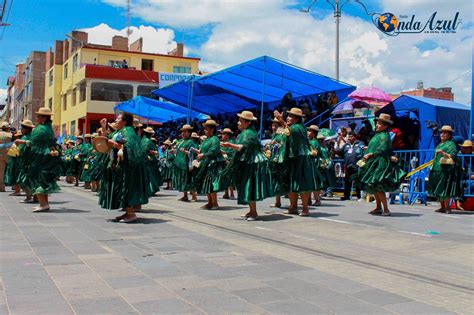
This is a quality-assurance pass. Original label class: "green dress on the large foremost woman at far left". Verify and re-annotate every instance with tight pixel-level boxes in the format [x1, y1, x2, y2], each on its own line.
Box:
[24, 121, 61, 195]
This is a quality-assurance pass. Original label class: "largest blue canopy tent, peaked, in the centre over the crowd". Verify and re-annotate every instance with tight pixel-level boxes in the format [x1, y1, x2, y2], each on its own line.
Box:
[152, 56, 355, 140]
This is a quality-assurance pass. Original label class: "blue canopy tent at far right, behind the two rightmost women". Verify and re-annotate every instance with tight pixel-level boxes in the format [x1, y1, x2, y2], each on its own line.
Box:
[376, 95, 470, 150]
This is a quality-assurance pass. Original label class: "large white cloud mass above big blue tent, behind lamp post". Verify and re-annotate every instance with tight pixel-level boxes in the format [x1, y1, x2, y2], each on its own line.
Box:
[99, 0, 472, 103]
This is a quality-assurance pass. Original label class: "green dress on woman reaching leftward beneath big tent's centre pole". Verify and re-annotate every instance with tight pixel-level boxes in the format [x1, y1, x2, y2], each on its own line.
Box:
[222, 126, 274, 205]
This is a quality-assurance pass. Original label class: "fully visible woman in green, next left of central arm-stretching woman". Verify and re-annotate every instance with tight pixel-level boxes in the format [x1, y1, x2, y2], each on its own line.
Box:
[193, 119, 225, 210]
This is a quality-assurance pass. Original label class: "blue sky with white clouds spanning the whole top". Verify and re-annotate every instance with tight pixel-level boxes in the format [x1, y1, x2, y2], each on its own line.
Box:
[0, 0, 472, 103]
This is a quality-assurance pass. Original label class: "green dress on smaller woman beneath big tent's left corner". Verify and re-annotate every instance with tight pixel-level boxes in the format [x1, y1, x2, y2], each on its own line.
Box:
[173, 139, 196, 192]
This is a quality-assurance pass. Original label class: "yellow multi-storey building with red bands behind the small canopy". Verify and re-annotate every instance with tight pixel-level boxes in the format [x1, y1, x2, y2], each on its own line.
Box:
[45, 45, 200, 136]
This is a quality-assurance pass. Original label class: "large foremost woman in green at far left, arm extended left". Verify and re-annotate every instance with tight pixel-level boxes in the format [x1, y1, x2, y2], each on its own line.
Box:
[15, 107, 61, 212]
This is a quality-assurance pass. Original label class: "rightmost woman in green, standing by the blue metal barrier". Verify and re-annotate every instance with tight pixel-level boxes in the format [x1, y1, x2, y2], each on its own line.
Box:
[428, 126, 462, 213]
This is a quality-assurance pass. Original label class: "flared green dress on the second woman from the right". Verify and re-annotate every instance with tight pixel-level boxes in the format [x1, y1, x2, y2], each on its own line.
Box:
[356, 131, 405, 194]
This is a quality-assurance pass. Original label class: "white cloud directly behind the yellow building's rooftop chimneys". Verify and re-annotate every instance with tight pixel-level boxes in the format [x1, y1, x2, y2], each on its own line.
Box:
[81, 23, 176, 54]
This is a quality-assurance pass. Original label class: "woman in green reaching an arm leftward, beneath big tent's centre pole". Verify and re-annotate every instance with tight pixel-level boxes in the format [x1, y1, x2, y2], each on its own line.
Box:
[221, 111, 273, 221]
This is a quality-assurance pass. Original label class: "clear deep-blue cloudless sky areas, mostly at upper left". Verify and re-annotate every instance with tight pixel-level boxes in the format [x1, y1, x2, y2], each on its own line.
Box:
[0, 0, 381, 74]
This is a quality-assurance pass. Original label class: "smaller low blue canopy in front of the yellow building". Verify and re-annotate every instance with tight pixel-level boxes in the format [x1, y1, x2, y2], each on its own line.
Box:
[114, 96, 208, 123]
